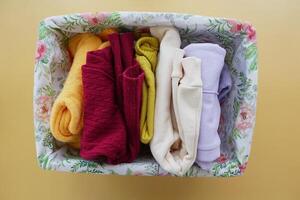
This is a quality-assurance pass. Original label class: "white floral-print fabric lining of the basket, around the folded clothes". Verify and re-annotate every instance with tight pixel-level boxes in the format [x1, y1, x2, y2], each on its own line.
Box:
[33, 12, 257, 177]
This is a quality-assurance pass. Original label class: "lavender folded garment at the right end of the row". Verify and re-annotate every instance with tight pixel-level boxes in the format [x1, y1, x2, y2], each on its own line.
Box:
[184, 43, 226, 170]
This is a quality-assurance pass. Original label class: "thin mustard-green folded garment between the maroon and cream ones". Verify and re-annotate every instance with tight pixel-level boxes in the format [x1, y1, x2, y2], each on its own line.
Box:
[135, 36, 159, 144]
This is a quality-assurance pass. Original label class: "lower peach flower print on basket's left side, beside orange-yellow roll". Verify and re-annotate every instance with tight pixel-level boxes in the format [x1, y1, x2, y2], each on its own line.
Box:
[35, 96, 51, 122]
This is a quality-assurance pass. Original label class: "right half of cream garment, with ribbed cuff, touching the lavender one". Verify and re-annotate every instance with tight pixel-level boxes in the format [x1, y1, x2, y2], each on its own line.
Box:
[171, 49, 202, 175]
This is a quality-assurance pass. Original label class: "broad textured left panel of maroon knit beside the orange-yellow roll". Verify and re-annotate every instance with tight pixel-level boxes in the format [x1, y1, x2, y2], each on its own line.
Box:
[80, 47, 127, 164]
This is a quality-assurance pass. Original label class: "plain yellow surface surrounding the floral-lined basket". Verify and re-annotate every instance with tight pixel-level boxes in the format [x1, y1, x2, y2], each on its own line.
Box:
[0, 0, 300, 200]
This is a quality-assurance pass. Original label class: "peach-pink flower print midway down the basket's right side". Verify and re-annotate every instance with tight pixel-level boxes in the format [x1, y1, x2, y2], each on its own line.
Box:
[237, 105, 254, 130]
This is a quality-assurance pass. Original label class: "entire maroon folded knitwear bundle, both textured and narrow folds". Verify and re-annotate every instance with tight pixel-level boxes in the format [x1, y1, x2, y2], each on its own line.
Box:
[80, 33, 144, 164]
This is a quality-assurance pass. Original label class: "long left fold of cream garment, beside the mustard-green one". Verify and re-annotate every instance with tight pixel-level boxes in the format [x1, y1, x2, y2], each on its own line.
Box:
[150, 27, 181, 173]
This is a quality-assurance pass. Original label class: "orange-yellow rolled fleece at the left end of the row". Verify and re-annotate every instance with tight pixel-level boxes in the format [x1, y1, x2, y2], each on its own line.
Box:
[50, 33, 101, 148]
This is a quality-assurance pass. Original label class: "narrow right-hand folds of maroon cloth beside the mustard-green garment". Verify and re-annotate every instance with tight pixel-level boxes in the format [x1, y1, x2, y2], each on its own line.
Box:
[108, 32, 144, 162]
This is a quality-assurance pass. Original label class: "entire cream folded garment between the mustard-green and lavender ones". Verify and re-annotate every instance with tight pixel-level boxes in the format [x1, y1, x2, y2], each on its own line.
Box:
[150, 27, 202, 176]
